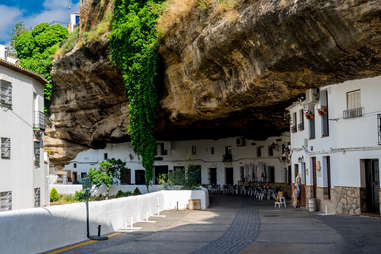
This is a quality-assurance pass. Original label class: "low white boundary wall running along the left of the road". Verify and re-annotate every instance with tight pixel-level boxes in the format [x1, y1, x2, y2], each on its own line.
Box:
[0, 189, 209, 254]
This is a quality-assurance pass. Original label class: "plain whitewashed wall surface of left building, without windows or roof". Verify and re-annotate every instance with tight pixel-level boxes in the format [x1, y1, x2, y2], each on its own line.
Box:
[0, 66, 49, 209]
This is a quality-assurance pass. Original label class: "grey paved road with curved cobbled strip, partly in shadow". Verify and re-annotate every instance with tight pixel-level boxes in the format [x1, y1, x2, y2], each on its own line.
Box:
[56, 196, 381, 254]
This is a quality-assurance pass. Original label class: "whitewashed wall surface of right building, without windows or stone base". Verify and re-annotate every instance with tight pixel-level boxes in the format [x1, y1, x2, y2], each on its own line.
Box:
[290, 77, 381, 187]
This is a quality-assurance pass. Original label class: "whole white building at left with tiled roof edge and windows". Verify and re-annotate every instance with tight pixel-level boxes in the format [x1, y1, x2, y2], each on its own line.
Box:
[0, 59, 49, 211]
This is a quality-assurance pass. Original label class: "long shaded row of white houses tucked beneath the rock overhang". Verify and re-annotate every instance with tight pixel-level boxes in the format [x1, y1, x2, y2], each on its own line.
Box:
[65, 134, 291, 188]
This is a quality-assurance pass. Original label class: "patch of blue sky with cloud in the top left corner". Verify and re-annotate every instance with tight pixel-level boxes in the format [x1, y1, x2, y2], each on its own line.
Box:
[0, 0, 79, 44]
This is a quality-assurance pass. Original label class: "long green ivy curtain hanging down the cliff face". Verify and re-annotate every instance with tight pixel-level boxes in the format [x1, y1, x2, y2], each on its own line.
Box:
[109, 0, 163, 189]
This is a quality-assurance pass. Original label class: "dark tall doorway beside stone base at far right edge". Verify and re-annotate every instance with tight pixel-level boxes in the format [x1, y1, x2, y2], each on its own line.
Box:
[365, 160, 380, 213]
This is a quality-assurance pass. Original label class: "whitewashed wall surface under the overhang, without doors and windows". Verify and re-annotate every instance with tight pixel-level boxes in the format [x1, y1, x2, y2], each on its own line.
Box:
[65, 136, 290, 184]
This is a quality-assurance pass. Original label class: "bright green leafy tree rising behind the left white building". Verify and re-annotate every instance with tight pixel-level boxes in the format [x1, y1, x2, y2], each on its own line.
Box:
[14, 23, 69, 112]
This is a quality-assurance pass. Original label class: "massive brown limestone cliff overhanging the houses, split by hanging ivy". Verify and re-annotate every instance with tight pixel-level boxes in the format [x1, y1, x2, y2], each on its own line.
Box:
[47, 0, 381, 169]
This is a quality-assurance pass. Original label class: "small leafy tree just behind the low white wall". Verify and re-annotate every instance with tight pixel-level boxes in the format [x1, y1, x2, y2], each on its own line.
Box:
[89, 158, 126, 198]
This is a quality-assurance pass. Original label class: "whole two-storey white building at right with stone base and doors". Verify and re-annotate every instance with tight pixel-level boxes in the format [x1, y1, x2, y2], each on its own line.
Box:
[288, 77, 381, 215]
